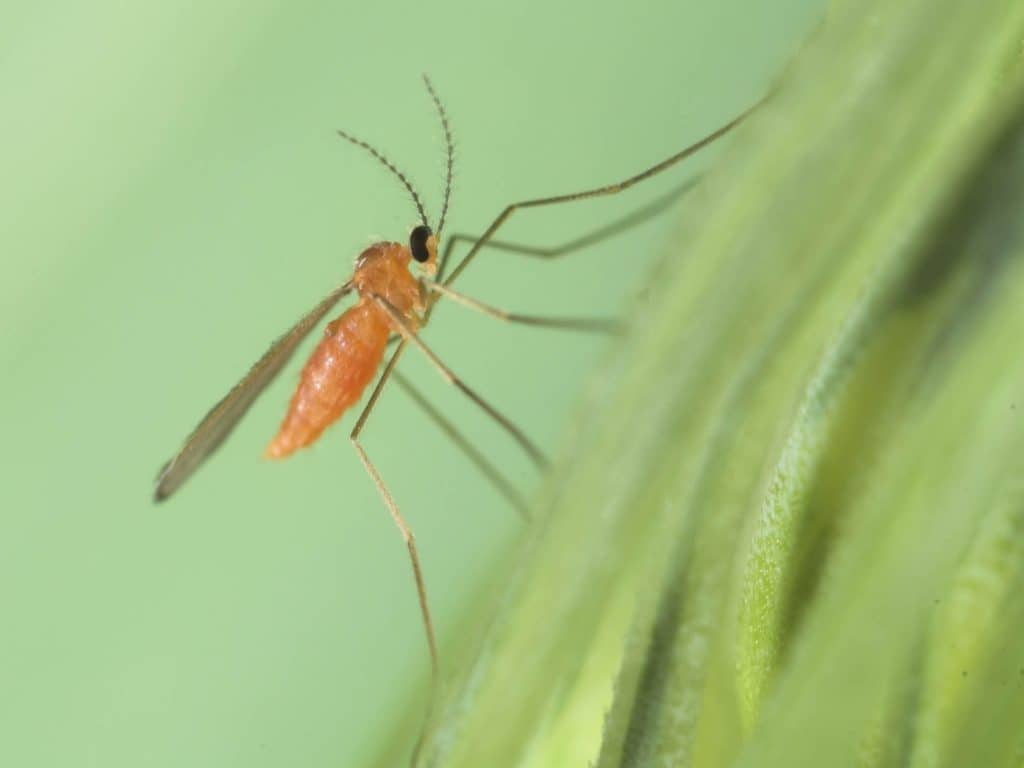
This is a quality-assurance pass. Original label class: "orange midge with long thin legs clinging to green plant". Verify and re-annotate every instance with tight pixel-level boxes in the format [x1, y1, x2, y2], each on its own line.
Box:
[154, 76, 756, 674]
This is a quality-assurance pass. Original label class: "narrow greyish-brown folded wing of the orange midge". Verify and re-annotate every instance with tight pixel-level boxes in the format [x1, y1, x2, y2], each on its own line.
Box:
[153, 283, 352, 502]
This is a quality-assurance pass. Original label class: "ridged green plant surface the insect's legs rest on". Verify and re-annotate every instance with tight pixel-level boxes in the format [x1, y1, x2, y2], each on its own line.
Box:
[374, 0, 1024, 768]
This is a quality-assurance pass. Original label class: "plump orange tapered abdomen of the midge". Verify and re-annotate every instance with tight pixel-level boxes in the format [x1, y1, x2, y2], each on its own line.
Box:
[265, 299, 389, 459]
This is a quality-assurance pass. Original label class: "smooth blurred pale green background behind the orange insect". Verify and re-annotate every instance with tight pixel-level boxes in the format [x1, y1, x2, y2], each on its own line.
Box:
[0, 0, 822, 766]
